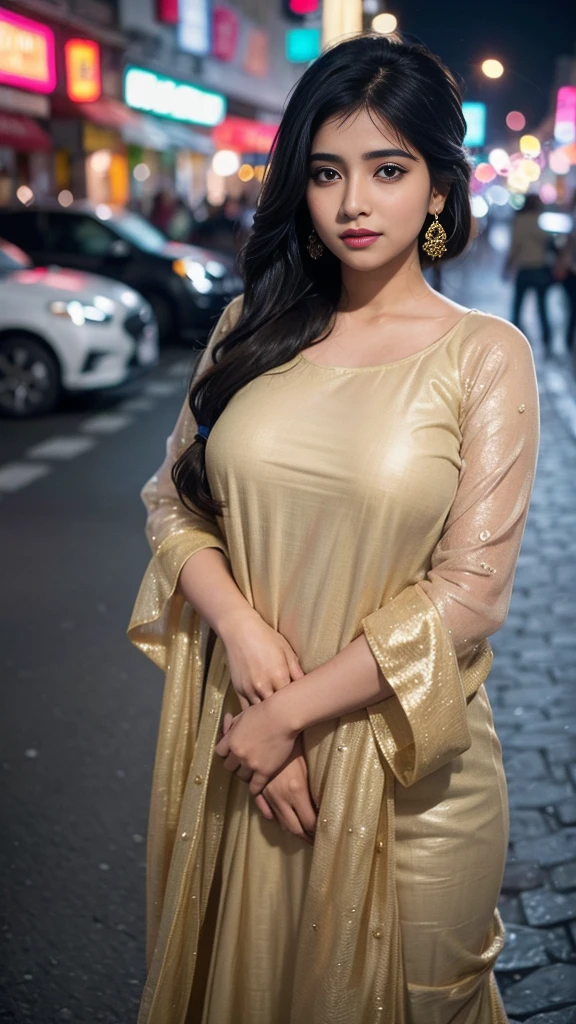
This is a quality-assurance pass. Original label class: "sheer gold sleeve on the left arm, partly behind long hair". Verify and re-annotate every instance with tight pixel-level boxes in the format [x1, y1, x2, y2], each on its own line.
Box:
[127, 295, 242, 670]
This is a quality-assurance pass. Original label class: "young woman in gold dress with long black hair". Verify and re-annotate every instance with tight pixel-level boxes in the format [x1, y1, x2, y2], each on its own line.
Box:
[128, 29, 539, 1024]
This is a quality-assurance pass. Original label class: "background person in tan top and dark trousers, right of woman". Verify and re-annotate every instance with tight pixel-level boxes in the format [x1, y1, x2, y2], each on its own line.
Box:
[504, 195, 552, 358]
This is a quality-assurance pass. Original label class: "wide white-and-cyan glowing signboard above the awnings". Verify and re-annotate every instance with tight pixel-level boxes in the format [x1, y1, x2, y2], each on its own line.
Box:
[124, 67, 227, 128]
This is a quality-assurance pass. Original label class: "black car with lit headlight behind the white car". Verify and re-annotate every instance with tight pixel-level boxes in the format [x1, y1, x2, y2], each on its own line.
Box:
[0, 203, 243, 345]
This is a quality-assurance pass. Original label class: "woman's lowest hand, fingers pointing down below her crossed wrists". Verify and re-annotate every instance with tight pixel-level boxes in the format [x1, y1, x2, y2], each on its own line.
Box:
[256, 735, 318, 844]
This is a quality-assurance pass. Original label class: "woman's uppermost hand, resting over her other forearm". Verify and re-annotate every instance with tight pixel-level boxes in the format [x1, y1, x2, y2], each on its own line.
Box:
[219, 609, 304, 711]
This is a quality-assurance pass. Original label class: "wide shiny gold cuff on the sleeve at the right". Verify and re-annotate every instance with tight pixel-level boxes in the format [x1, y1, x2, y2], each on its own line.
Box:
[361, 584, 483, 786]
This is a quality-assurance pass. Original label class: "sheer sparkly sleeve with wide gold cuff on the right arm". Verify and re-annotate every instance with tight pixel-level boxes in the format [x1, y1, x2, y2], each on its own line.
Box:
[361, 316, 540, 786]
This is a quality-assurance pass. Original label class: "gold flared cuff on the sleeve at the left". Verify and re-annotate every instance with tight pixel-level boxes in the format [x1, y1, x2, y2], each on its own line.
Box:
[126, 529, 229, 672]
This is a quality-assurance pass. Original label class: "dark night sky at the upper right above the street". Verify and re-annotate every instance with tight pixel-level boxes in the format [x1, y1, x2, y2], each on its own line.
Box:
[385, 0, 576, 141]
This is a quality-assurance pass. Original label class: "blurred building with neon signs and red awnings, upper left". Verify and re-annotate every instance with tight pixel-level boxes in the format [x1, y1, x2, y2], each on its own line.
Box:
[0, 0, 314, 209]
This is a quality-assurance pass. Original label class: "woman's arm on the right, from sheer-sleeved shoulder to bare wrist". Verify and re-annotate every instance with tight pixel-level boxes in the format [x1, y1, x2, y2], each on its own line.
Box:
[275, 321, 539, 729]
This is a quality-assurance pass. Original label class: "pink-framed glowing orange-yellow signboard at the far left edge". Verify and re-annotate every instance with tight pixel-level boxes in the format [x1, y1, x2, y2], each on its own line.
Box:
[0, 8, 56, 92]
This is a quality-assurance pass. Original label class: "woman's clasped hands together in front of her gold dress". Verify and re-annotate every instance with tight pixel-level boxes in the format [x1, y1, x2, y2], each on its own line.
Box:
[215, 609, 317, 843]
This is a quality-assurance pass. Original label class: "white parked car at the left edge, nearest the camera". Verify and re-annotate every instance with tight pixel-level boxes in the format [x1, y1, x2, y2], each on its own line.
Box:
[0, 240, 158, 418]
